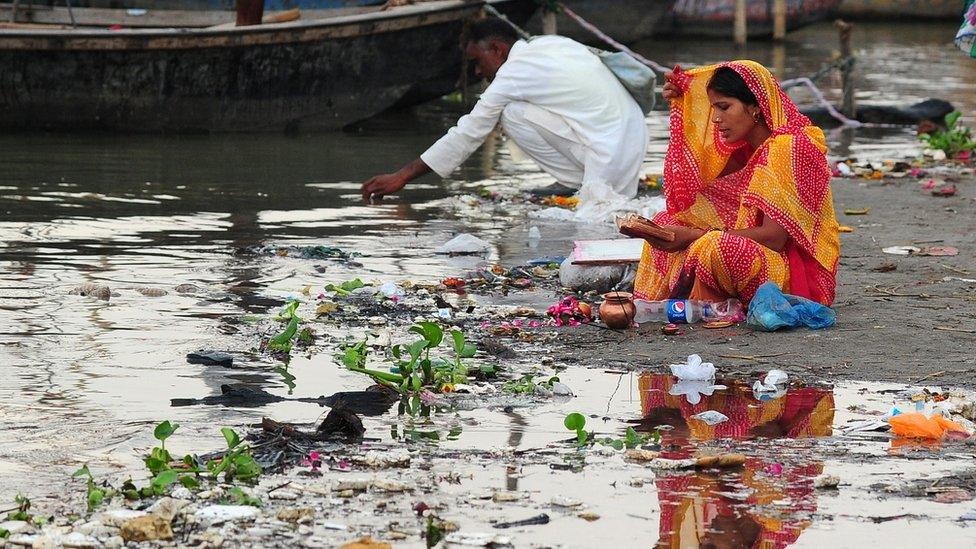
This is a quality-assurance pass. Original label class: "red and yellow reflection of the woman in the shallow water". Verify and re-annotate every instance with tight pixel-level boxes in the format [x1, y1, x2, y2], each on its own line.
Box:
[639, 374, 834, 549]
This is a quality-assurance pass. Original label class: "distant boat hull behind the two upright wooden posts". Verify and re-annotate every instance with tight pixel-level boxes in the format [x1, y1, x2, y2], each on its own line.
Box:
[659, 0, 841, 38]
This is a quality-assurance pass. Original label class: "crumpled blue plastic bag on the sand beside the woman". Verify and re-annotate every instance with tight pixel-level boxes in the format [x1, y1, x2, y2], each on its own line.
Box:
[746, 282, 837, 332]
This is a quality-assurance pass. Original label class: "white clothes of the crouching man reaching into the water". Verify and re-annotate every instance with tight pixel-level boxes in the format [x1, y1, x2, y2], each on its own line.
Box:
[420, 36, 647, 197]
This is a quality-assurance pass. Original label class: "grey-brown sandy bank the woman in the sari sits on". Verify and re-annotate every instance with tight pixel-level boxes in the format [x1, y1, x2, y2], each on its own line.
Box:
[552, 176, 976, 388]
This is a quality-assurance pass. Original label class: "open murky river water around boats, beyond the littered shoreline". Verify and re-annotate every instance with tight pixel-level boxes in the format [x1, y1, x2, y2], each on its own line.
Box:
[0, 18, 976, 528]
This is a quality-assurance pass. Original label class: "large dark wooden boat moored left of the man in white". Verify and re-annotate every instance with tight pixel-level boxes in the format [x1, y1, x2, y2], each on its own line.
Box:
[0, 0, 536, 132]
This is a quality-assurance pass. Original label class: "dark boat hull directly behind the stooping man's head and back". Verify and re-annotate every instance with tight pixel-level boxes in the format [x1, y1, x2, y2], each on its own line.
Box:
[528, 0, 674, 45]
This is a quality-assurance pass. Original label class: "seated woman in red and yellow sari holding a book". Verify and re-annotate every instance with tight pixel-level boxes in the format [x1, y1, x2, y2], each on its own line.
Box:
[634, 61, 840, 305]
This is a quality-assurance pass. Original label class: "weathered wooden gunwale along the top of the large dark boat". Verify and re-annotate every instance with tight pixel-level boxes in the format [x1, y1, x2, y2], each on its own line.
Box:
[0, 0, 515, 51]
